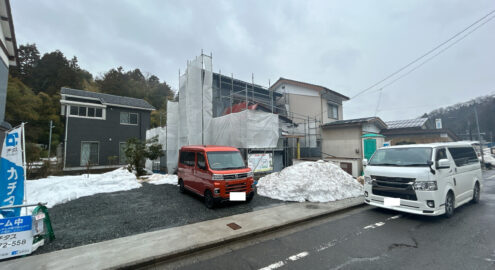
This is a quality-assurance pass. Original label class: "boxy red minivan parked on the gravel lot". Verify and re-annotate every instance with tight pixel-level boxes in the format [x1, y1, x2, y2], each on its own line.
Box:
[177, 145, 255, 208]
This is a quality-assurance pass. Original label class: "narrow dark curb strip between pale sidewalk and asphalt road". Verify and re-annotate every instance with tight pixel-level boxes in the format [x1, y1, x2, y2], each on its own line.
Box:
[117, 197, 365, 269]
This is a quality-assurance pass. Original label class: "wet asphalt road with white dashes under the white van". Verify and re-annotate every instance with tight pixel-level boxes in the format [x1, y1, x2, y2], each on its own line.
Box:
[169, 170, 495, 270]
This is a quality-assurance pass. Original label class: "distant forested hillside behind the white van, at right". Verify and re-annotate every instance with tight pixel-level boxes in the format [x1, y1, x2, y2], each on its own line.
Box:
[427, 94, 495, 141]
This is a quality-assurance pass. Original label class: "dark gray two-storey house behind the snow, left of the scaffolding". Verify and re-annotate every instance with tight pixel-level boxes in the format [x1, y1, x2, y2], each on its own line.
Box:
[60, 87, 155, 170]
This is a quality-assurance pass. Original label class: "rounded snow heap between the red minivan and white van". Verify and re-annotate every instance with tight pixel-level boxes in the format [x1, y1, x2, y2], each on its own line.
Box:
[257, 160, 363, 202]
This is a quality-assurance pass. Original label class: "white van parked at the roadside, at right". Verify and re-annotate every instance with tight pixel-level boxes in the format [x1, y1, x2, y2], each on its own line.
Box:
[363, 143, 483, 217]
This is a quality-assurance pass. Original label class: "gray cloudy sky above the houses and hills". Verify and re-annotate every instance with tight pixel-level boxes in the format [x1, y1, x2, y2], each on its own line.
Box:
[11, 0, 495, 120]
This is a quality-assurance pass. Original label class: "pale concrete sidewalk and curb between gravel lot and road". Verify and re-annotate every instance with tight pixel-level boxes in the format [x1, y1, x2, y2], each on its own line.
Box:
[0, 196, 364, 270]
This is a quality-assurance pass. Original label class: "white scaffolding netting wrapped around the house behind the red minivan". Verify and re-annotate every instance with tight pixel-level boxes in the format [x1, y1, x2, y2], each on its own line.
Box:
[146, 55, 279, 173]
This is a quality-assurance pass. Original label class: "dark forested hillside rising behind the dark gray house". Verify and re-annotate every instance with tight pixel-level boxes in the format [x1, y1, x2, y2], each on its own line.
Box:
[5, 44, 174, 157]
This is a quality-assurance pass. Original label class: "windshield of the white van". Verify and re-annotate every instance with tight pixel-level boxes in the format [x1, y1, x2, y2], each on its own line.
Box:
[368, 147, 432, 167]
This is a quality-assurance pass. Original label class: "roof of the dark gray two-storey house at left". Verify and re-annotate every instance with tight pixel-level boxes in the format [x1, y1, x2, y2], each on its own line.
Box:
[60, 87, 155, 110]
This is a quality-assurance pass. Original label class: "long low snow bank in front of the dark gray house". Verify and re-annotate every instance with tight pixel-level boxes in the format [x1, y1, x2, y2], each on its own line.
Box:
[26, 168, 141, 210]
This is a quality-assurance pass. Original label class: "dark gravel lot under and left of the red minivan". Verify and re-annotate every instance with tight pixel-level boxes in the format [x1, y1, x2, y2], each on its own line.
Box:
[34, 183, 283, 254]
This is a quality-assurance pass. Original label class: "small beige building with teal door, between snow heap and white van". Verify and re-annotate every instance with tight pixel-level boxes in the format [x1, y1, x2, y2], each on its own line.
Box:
[321, 117, 387, 177]
